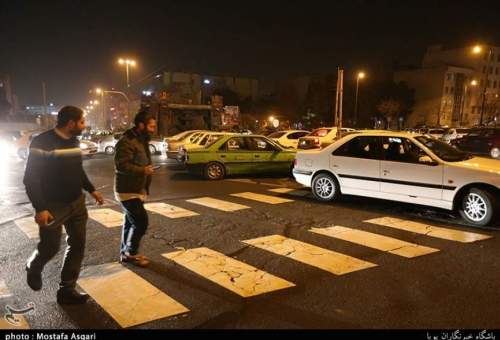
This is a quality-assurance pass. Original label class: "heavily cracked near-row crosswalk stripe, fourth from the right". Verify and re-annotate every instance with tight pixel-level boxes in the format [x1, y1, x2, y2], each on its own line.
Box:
[162, 248, 295, 297]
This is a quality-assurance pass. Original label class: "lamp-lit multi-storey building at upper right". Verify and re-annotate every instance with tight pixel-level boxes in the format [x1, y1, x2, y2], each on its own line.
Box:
[394, 46, 500, 126]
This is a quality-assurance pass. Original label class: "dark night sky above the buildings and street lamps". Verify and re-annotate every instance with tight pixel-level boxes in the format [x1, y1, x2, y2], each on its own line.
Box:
[0, 0, 500, 105]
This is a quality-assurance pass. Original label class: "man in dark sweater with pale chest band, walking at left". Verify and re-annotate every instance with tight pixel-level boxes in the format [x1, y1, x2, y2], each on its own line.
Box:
[23, 106, 103, 304]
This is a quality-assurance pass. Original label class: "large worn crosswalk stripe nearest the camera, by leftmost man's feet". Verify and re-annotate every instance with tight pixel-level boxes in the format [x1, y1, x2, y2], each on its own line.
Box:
[78, 263, 189, 328]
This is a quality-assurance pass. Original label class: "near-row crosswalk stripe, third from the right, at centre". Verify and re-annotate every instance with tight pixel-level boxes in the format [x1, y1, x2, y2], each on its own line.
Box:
[242, 235, 377, 275]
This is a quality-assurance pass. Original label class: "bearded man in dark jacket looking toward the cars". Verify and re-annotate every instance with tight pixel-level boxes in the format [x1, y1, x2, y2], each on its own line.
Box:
[115, 112, 156, 267]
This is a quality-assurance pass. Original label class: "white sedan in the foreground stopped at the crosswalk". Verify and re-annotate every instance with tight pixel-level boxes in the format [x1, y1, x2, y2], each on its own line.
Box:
[293, 131, 500, 226]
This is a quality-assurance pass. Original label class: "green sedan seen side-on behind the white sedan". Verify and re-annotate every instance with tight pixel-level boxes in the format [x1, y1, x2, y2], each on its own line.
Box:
[185, 134, 295, 180]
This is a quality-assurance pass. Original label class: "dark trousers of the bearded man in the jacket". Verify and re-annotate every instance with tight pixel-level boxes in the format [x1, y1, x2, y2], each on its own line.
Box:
[120, 198, 148, 255]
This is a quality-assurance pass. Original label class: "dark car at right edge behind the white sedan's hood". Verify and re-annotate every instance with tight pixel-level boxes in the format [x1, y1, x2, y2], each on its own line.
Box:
[452, 128, 500, 159]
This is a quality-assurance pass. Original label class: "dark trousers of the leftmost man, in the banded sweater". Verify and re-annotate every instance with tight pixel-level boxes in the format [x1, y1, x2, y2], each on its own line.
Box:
[28, 194, 88, 288]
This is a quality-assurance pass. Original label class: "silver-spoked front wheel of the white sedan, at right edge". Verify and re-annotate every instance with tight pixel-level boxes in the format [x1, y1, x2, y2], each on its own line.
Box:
[459, 188, 498, 226]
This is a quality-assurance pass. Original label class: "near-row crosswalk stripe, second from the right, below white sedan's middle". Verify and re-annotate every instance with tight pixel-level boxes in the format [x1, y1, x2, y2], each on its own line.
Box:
[310, 226, 439, 258]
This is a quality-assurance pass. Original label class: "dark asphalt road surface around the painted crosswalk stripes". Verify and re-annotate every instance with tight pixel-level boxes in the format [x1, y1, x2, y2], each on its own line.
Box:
[0, 156, 500, 329]
